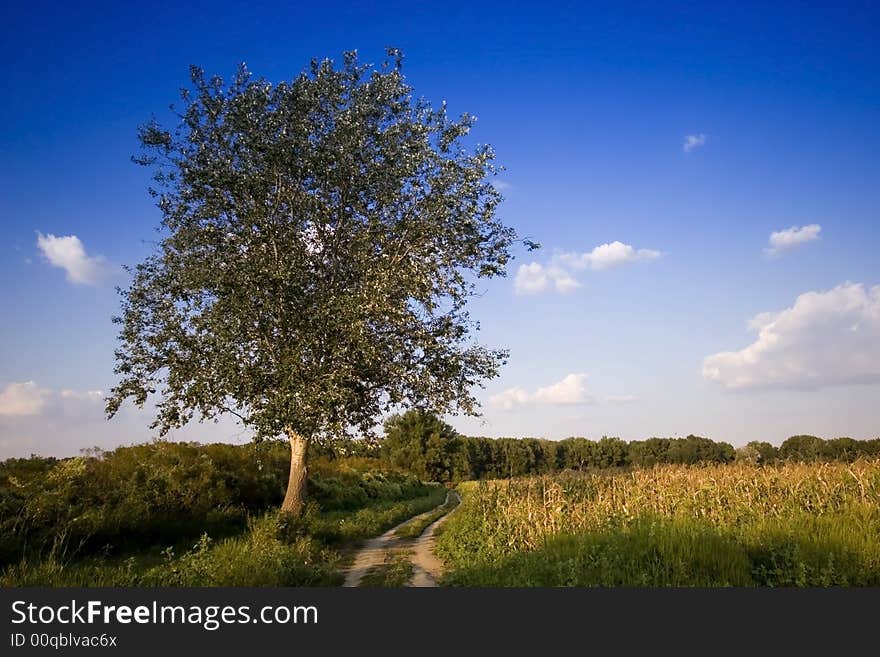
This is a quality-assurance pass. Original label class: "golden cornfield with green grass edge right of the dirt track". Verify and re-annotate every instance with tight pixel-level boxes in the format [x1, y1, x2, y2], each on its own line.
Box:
[438, 461, 880, 586]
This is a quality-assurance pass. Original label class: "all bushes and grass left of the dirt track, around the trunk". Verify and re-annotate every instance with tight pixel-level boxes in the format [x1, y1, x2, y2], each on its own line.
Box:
[0, 442, 445, 586]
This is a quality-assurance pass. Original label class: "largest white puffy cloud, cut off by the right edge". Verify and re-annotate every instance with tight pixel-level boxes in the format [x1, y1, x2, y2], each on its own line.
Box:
[703, 282, 880, 389]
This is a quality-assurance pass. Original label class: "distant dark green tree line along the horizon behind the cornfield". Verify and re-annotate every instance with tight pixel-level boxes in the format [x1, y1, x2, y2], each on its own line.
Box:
[374, 410, 880, 481]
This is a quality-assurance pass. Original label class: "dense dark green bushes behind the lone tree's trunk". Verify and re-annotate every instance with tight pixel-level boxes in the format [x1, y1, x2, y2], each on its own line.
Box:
[0, 441, 429, 565]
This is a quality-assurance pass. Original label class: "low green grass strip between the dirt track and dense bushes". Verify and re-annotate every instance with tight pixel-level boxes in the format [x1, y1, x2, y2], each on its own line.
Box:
[0, 486, 445, 587]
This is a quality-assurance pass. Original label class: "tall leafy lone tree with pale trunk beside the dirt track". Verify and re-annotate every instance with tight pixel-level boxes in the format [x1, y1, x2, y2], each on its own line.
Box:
[107, 50, 535, 514]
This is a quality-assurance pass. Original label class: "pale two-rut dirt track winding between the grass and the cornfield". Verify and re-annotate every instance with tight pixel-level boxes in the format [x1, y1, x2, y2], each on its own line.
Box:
[343, 491, 458, 587]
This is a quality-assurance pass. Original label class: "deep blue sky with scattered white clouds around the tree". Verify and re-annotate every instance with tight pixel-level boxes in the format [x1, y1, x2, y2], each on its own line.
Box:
[0, 2, 880, 457]
